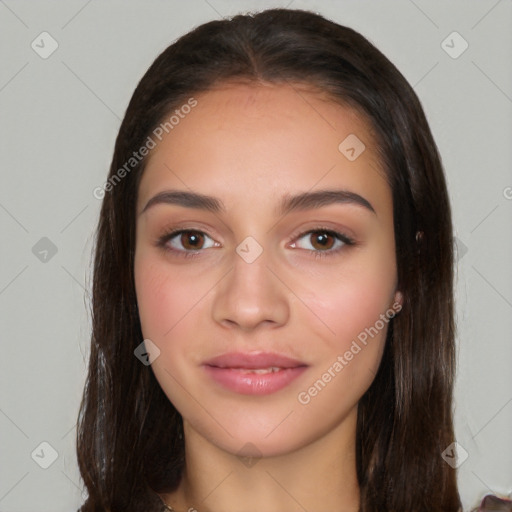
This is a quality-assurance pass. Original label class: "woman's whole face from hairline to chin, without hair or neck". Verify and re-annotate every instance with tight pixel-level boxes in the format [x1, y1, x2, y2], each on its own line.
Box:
[134, 84, 401, 456]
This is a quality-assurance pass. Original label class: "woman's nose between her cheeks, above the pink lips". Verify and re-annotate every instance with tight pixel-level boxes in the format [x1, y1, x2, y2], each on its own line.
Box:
[213, 244, 292, 332]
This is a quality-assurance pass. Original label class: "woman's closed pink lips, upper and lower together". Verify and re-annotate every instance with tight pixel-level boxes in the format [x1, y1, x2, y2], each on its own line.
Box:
[203, 353, 307, 395]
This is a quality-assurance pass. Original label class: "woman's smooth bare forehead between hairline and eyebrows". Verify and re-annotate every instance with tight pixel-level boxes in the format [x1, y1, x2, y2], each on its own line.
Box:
[139, 83, 389, 216]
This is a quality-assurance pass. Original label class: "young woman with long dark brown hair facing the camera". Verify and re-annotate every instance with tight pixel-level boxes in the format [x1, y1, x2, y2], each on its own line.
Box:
[77, 9, 508, 512]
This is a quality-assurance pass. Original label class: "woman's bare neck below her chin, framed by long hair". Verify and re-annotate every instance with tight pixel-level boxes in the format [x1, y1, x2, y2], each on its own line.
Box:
[163, 410, 359, 512]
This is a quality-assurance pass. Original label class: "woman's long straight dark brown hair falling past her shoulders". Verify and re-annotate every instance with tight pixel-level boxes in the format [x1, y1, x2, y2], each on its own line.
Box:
[76, 9, 461, 512]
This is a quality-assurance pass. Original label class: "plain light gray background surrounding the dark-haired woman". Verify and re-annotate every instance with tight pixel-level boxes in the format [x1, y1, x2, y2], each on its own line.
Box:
[0, 0, 512, 512]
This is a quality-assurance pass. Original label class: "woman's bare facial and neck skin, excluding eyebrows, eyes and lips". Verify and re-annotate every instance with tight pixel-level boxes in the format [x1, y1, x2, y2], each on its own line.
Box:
[134, 84, 401, 512]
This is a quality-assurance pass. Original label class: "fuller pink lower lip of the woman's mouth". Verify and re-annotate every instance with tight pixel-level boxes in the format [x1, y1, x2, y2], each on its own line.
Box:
[203, 365, 307, 395]
